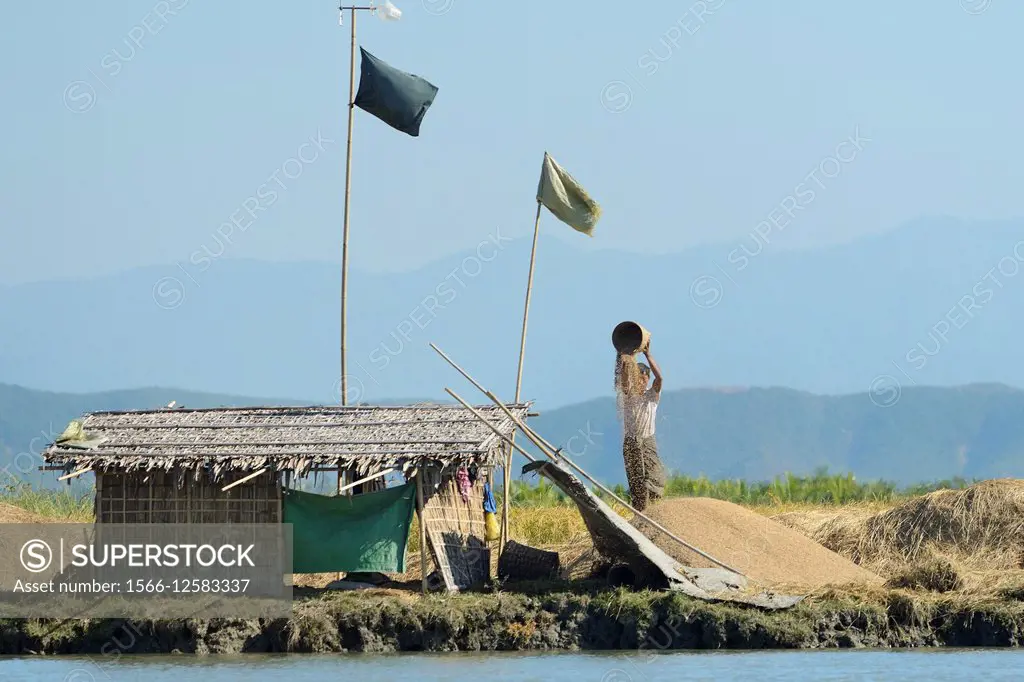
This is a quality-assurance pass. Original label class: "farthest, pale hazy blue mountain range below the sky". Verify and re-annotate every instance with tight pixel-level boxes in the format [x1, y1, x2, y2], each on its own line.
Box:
[6, 219, 1024, 405]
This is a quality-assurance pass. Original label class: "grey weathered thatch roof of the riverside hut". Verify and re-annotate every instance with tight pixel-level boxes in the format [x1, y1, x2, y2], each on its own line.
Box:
[43, 403, 529, 479]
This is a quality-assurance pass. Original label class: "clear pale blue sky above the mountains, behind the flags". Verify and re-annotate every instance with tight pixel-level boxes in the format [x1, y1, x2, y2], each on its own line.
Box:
[0, 0, 1024, 284]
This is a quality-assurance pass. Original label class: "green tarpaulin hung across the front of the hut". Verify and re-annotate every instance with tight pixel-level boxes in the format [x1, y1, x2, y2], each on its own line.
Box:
[284, 483, 416, 573]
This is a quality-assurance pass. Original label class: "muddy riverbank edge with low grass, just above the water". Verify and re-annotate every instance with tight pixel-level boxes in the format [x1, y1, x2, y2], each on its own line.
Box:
[6, 586, 1024, 655]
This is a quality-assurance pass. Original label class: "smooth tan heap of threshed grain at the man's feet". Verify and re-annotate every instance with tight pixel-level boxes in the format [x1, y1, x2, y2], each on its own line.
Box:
[633, 498, 882, 590]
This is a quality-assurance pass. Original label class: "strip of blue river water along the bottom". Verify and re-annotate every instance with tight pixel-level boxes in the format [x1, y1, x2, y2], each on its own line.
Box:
[0, 649, 1024, 682]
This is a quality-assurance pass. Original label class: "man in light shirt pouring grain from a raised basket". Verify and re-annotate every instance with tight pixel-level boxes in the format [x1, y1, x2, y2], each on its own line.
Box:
[617, 348, 666, 511]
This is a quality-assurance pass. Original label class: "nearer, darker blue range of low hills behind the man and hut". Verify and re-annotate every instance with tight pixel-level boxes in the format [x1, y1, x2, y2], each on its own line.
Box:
[8, 384, 1024, 485]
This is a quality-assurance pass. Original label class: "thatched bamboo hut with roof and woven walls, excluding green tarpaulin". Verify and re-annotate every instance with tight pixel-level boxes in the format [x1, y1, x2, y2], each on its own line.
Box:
[43, 403, 528, 589]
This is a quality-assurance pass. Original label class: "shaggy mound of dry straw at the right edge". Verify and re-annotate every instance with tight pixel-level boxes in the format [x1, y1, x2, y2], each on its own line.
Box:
[811, 479, 1024, 573]
